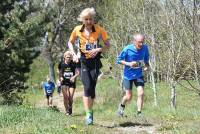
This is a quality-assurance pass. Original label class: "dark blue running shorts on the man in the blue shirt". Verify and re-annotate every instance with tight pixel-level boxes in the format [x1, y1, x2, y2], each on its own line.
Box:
[123, 76, 144, 90]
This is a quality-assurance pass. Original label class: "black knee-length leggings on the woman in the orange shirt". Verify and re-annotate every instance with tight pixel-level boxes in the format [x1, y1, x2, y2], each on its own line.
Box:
[81, 60, 99, 99]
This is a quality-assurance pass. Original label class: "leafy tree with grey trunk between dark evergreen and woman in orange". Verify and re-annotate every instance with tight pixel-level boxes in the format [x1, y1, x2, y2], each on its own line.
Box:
[39, 0, 102, 81]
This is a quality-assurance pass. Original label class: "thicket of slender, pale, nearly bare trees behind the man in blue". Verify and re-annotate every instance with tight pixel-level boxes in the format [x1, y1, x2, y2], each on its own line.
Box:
[98, 0, 200, 85]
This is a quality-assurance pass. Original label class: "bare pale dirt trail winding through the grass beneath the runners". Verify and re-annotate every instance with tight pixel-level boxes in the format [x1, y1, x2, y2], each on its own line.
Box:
[36, 91, 159, 134]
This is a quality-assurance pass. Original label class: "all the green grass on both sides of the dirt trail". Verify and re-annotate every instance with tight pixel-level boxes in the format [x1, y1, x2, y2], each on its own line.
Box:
[0, 57, 200, 134]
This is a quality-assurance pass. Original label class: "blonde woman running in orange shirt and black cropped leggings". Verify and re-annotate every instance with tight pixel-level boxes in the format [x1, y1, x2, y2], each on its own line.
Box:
[68, 8, 110, 125]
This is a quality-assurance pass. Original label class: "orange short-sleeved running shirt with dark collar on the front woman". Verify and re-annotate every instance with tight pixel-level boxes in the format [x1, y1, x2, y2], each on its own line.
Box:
[69, 24, 108, 59]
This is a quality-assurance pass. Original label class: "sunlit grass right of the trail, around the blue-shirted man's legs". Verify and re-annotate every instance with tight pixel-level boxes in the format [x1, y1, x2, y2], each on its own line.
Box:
[95, 78, 200, 134]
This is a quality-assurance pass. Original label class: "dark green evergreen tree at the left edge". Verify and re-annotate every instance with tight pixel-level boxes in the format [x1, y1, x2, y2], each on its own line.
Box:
[0, 1, 45, 103]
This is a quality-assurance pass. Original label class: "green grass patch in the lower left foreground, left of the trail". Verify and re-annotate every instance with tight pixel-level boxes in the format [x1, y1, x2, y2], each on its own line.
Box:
[0, 106, 90, 134]
